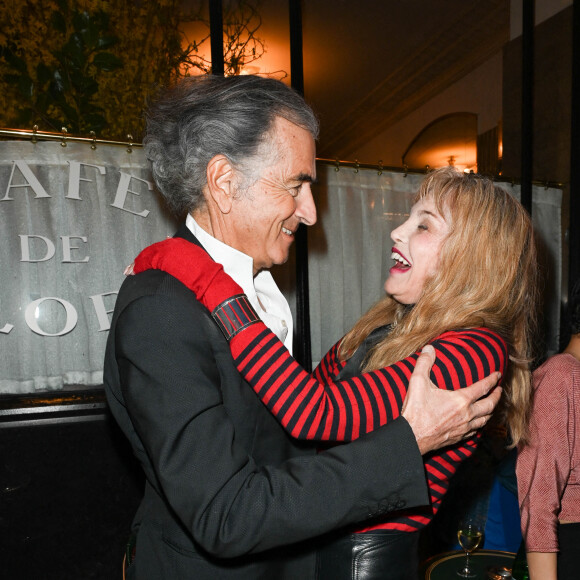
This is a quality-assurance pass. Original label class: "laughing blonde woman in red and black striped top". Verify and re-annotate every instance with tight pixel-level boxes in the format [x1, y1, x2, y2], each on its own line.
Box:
[134, 168, 537, 580]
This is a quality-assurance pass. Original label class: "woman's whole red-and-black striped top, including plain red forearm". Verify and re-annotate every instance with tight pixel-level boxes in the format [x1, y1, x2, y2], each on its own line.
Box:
[130, 238, 508, 531]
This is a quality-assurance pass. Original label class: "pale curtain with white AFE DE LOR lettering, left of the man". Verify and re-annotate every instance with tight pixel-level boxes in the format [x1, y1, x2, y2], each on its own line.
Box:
[0, 141, 175, 393]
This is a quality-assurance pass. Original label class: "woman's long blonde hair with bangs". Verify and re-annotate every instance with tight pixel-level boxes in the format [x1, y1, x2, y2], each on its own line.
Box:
[341, 167, 539, 445]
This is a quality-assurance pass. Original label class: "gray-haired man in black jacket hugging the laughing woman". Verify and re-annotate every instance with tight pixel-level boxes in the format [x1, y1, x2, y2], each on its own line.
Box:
[105, 76, 499, 580]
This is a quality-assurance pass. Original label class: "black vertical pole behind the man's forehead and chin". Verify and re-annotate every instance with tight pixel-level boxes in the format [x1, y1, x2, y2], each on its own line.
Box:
[289, 0, 312, 371]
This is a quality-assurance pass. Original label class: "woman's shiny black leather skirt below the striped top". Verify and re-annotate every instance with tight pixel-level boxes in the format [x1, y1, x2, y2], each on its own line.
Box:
[317, 530, 419, 580]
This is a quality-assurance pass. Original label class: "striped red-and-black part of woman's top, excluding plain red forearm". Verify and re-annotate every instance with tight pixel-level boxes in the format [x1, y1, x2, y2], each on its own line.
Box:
[230, 323, 508, 532]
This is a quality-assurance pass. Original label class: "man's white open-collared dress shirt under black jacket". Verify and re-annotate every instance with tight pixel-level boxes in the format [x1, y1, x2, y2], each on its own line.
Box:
[185, 215, 293, 353]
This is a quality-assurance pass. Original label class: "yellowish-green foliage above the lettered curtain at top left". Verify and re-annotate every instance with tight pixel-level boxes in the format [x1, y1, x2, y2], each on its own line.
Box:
[0, 0, 264, 141]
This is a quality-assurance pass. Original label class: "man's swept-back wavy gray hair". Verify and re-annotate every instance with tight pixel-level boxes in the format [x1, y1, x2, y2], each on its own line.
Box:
[143, 75, 318, 217]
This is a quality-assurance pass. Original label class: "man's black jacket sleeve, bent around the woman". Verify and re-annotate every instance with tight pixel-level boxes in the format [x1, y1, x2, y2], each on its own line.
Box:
[112, 274, 429, 557]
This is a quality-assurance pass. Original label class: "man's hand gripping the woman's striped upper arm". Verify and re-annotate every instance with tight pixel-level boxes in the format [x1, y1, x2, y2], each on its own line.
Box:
[402, 345, 501, 454]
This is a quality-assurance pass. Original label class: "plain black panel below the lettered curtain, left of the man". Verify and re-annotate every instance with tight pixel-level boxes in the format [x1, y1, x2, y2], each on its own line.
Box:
[0, 410, 142, 580]
